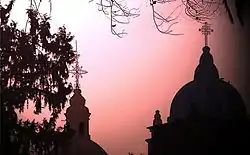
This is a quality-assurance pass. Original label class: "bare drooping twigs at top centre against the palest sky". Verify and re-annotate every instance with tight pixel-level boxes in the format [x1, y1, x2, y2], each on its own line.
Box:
[90, 0, 140, 38]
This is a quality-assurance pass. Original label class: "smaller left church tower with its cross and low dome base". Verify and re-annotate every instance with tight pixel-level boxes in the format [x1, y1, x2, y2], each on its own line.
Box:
[60, 41, 107, 155]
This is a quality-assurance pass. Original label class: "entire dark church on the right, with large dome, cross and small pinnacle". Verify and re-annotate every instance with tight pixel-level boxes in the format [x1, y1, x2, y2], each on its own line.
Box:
[146, 23, 250, 155]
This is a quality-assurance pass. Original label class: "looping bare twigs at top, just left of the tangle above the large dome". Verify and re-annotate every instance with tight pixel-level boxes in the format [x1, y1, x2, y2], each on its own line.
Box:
[150, 0, 183, 35]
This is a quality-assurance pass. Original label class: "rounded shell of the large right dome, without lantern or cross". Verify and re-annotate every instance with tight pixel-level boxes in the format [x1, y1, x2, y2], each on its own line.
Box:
[170, 80, 246, 120]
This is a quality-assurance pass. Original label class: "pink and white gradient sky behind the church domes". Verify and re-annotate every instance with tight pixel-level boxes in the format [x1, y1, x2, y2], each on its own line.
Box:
[3, 0, 249, 155]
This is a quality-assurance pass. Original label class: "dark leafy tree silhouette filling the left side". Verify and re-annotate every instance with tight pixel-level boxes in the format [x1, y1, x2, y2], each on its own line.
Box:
[0, 0, 76, 155]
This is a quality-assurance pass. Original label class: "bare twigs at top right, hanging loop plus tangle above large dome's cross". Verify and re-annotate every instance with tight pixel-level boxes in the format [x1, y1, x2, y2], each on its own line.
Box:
[150, 0, 224, 35]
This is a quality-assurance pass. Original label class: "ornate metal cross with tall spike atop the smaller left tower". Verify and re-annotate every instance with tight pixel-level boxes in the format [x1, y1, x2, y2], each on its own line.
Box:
[69, 41, 88, 89]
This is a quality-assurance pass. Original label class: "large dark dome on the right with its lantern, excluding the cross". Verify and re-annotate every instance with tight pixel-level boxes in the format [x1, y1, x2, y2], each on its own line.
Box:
[169, 47, 246, 121]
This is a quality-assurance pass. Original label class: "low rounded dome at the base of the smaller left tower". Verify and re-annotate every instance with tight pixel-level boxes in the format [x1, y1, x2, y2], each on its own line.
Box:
[70, 139, 107, 155]
